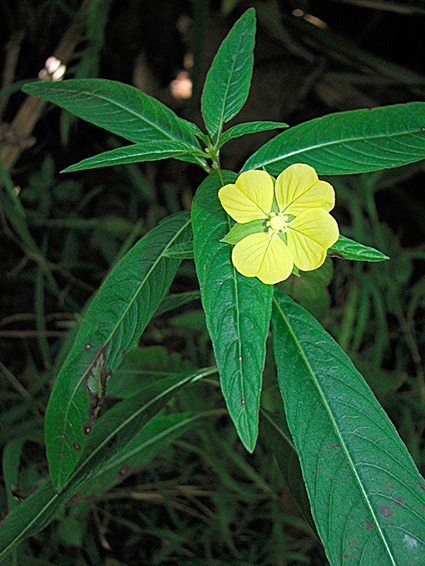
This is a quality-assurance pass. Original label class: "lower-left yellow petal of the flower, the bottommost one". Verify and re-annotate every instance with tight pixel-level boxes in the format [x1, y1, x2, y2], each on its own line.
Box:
[232, 232, 294, 285]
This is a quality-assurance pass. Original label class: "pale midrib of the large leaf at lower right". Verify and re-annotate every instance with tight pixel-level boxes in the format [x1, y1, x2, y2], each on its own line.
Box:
[273, 297, 396, 566]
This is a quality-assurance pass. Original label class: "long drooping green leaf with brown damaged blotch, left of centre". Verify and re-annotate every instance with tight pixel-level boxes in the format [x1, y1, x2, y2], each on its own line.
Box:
[45, 212, 191, 491]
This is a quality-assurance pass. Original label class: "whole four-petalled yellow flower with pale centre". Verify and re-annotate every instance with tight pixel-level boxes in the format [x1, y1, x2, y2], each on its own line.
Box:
[218, 163, 339, 285]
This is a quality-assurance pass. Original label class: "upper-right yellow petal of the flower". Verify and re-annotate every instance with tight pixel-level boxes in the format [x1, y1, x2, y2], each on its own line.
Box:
[275, 163, 335, 216]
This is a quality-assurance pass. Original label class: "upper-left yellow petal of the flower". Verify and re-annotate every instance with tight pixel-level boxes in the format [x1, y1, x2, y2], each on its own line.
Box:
[218, 171, 273, 224]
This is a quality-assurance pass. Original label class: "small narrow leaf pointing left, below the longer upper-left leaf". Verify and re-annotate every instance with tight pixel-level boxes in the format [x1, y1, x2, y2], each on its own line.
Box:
[61, 140, 206, 173]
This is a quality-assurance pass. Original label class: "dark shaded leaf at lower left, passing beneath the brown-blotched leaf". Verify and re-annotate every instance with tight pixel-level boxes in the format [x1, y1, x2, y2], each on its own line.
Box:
[0, 368, 216, 560]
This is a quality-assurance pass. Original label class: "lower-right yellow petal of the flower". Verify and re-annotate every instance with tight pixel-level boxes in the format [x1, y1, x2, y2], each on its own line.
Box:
[286, 208, 339, 271]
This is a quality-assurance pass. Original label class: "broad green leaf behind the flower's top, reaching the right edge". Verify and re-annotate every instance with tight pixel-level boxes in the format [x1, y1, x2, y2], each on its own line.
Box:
[241, 102, 425, 175]
